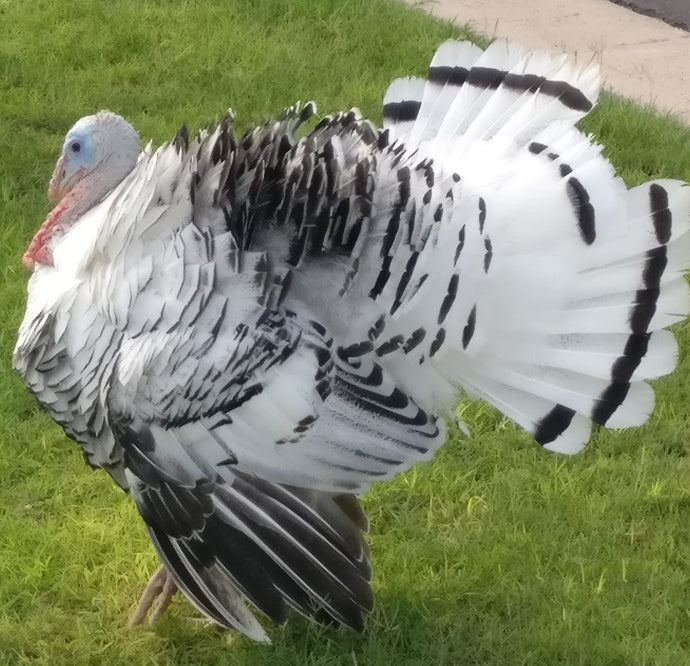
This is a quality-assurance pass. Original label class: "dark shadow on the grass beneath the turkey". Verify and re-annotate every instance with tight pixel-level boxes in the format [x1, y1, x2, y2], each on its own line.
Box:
[127, 581, 631, 666]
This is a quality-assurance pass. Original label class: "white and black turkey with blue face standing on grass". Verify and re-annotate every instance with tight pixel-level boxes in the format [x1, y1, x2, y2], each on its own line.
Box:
[14, 41, 690, 640]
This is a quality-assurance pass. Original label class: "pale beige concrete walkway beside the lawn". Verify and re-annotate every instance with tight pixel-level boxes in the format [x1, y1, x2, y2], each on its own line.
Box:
[403, 0, 690, 124]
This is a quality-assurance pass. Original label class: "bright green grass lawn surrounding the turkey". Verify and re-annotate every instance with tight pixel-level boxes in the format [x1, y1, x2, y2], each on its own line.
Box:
[0, 0, 690, 666]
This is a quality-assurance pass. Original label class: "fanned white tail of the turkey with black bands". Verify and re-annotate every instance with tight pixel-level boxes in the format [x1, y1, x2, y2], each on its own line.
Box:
[370, 42, 690, 453]
